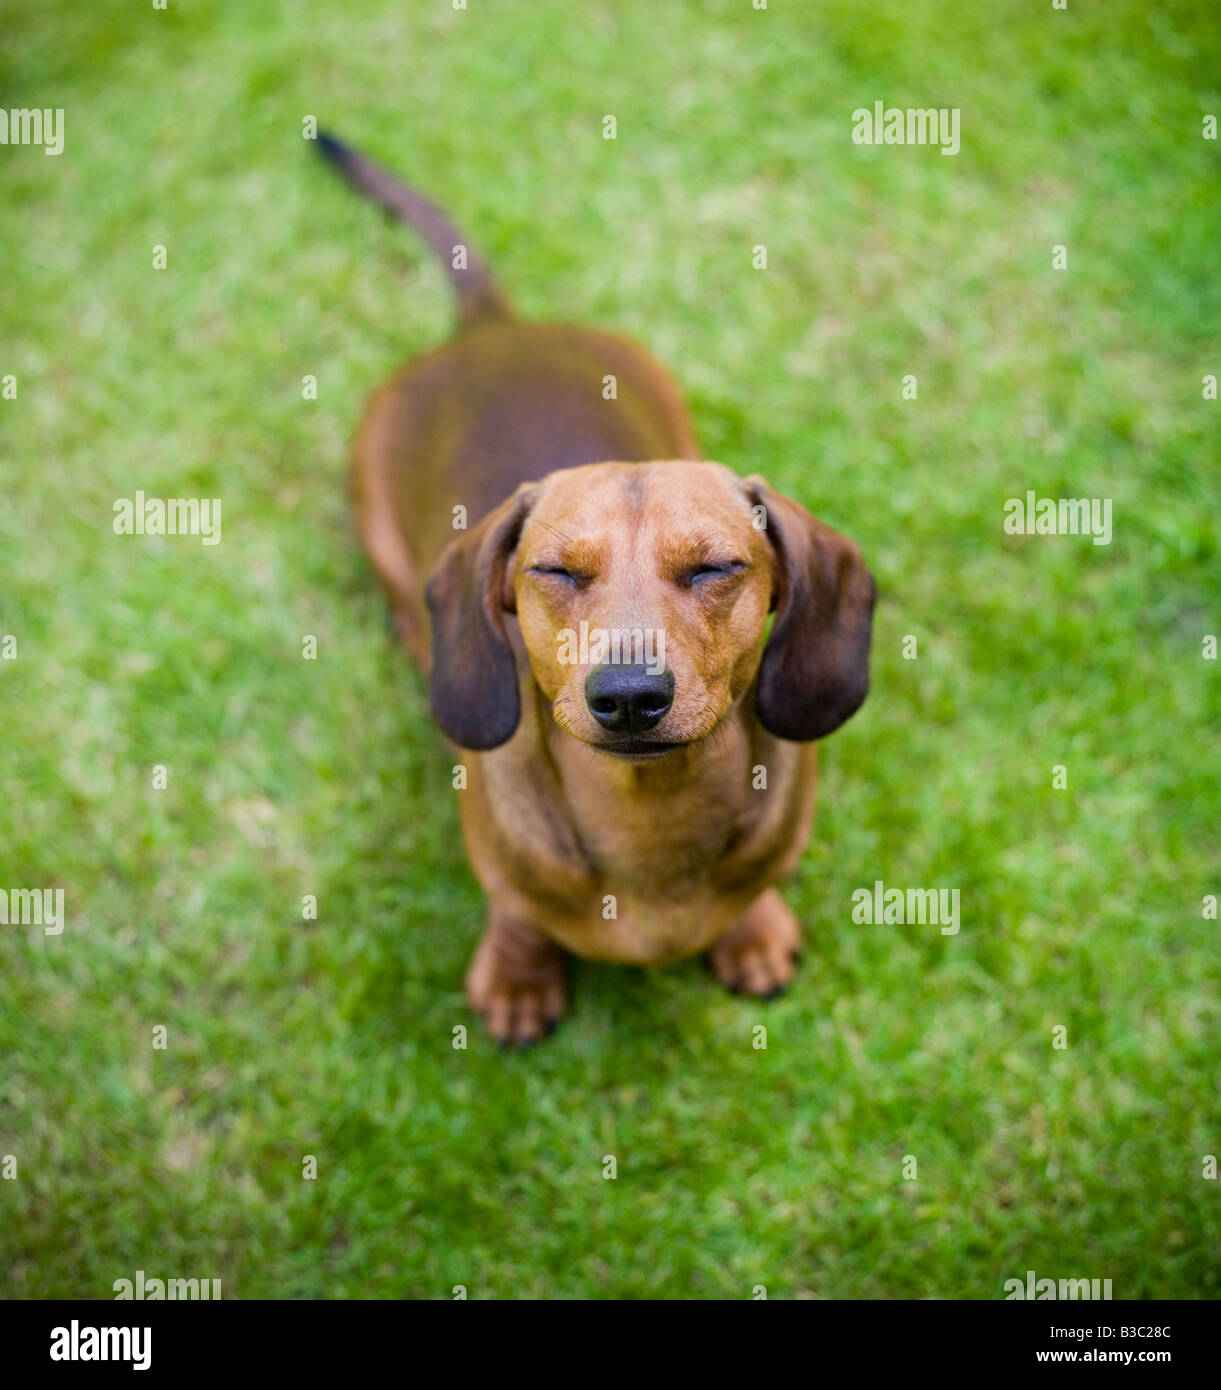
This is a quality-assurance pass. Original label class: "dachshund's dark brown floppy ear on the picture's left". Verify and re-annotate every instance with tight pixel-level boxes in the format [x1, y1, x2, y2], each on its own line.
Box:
[424, 487, 534, 751]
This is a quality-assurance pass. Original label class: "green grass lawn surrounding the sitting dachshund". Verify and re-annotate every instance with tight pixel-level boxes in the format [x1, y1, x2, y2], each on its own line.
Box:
[0, 0, 1221, 1298]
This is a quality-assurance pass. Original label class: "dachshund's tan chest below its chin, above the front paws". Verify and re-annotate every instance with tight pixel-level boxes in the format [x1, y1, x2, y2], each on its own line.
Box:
[464, 734, 814, 965]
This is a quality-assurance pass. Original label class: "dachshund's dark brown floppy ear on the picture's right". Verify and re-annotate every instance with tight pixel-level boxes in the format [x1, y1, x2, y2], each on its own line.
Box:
[747, 477, 878, 742]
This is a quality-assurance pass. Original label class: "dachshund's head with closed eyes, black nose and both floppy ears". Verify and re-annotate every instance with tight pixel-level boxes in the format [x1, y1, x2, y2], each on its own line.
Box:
[427, 461, 875, 759]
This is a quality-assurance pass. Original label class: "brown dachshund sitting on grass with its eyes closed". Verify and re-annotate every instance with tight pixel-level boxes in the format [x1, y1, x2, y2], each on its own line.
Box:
[318, 136, 875, 1043]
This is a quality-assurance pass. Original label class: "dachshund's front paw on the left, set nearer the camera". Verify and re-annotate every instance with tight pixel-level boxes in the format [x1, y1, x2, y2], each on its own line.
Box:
[466, 913, 567, 1047]
